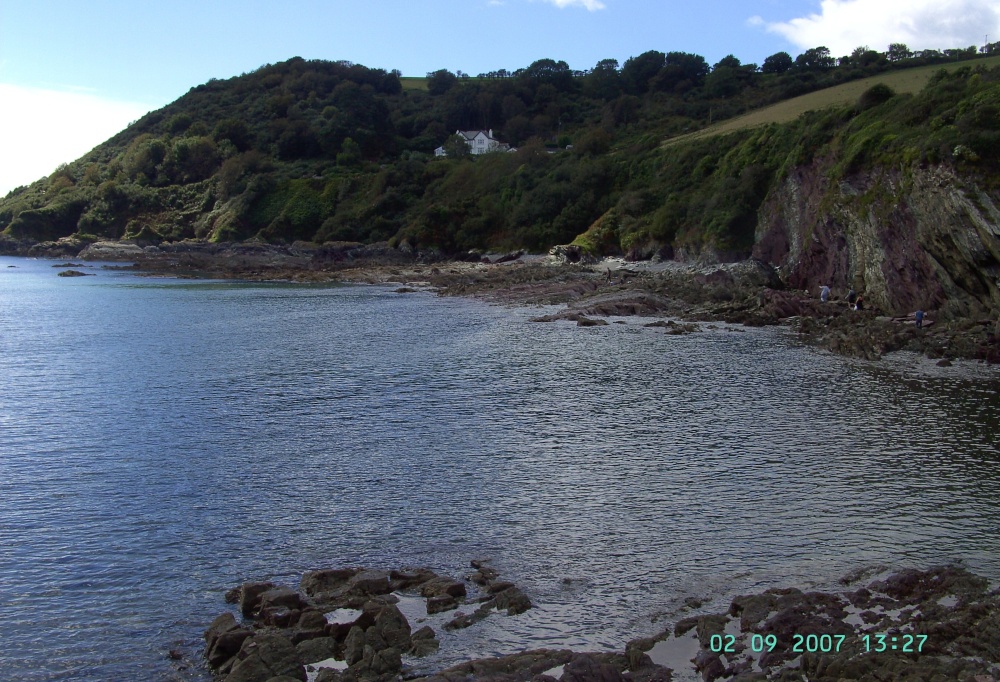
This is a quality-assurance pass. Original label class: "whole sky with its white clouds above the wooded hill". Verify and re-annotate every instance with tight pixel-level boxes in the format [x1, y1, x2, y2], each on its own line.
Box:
[0, 0, 1000, 195]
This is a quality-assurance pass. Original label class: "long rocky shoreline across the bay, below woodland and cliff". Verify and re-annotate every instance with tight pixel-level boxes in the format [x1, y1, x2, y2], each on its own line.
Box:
[7, 238, 1000, 365]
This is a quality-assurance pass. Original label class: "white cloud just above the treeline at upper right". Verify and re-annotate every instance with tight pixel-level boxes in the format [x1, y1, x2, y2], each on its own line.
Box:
[749, 0, 1000, 57]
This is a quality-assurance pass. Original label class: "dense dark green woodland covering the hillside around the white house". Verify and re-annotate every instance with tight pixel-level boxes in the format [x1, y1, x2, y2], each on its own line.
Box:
[0, 45, 1000, 257]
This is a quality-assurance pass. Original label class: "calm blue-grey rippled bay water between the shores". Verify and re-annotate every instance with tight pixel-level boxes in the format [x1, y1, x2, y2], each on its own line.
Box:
[0, 252, 1000, 680]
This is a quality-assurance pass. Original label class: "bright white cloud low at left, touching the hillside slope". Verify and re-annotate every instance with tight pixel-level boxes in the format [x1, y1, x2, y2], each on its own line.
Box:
[0, 83, 153, 197]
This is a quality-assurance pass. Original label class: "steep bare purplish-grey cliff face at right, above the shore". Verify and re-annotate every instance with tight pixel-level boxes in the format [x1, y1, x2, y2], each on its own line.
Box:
[754, 162, 1000, 317]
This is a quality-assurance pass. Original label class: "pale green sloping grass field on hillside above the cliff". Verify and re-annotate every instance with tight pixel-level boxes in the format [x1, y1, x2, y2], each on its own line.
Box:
[663, 57, 1000, 147]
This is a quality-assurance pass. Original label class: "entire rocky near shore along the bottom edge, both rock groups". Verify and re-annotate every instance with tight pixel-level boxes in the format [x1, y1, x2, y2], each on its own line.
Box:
[205, 560, 1000, 682]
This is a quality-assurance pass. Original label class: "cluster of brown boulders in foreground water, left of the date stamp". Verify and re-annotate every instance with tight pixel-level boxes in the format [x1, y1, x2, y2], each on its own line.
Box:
[205, 560, 531, 682]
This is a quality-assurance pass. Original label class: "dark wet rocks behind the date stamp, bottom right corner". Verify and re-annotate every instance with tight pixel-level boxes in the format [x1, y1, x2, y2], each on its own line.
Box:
[626, 566, 1000, 682]
